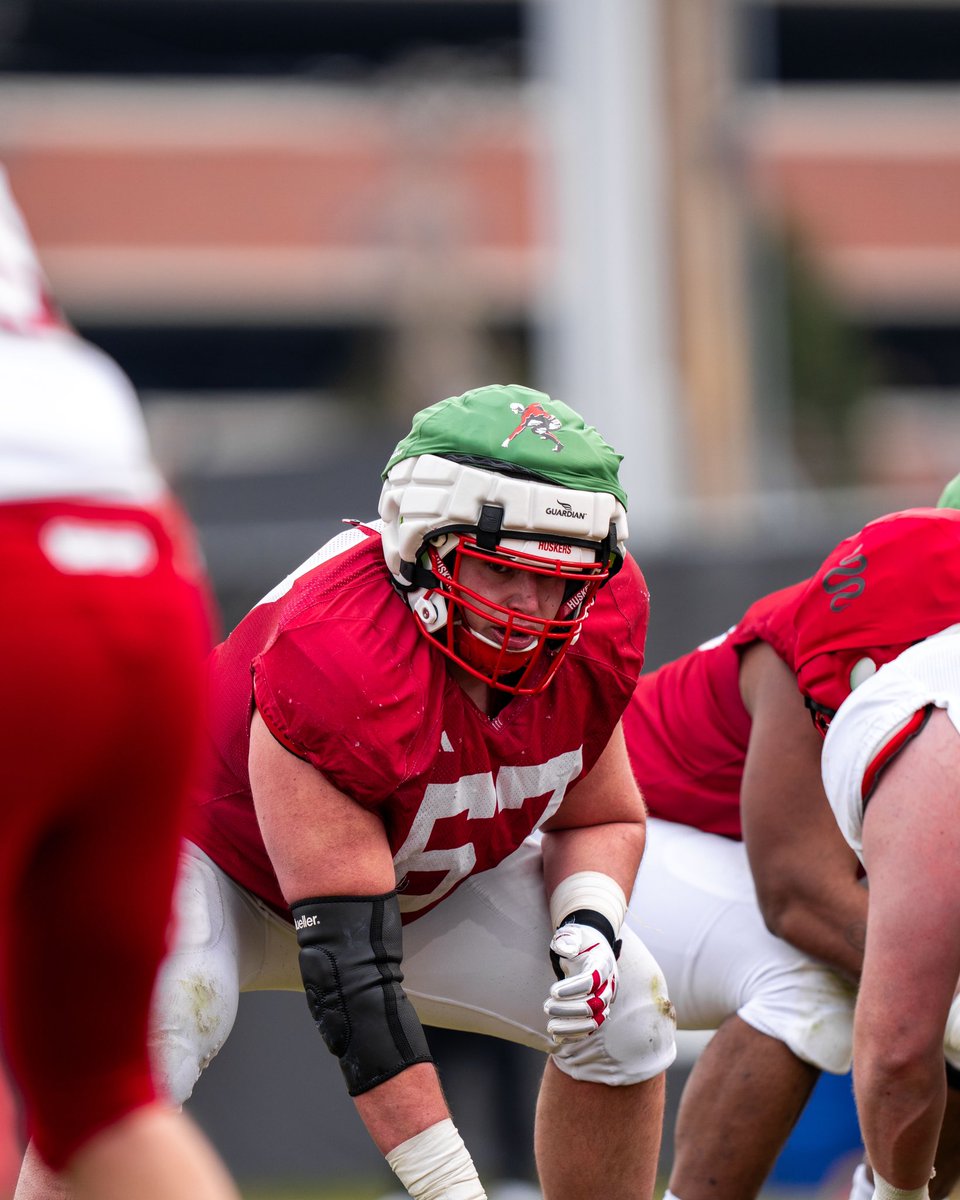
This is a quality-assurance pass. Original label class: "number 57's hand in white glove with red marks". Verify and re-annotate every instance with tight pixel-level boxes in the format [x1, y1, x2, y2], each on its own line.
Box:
[544, 924, 619, 1044]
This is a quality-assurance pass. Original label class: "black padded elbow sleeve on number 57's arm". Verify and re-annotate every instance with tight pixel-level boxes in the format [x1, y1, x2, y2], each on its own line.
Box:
[290, 892, 433, 1096]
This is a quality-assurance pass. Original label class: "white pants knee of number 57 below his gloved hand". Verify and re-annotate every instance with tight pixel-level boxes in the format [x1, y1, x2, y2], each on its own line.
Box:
[552, 928, 677, 1087]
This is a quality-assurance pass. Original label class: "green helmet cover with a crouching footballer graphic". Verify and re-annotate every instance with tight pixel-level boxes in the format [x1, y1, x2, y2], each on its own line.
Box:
[383, 384, 626, 508]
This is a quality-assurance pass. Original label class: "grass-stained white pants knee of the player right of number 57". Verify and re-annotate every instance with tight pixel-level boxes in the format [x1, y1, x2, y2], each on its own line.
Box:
[737, 956, 857, 1075]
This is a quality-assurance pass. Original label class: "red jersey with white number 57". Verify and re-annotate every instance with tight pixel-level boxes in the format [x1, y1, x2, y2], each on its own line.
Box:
[191, 527, 649, 920]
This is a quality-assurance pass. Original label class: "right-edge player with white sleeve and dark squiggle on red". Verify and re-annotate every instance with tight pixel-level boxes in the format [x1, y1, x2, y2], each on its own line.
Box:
[797, 509, 960, 1200]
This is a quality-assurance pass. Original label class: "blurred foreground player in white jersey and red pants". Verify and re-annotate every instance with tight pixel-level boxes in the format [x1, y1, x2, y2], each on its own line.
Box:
[0, 166, 238, 1200]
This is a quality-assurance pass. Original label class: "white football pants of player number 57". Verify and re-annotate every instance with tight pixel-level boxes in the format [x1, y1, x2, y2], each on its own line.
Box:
[152, 841, 676, 1103]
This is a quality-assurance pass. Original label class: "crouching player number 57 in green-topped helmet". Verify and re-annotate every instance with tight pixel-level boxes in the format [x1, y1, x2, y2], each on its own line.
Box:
[116, 386, 674, 1200]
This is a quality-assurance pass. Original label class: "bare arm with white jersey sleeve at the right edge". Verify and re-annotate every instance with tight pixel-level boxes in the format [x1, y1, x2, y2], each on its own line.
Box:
[823, 625, 960, 1200]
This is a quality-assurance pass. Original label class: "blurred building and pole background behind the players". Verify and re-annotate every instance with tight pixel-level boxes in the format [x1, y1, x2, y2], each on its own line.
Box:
[0, 0, 960, 1200]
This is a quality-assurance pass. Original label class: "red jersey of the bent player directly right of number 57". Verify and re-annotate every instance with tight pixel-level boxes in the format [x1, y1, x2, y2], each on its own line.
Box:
[623, 580, 806, 838]
